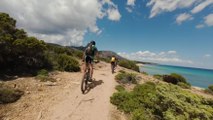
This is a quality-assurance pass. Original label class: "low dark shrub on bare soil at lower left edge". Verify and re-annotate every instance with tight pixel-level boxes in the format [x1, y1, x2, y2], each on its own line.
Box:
[0, 88, 24, 104]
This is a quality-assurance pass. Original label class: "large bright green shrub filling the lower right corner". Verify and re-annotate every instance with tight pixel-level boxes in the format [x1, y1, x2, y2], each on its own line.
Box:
[110, 82, 213, 120]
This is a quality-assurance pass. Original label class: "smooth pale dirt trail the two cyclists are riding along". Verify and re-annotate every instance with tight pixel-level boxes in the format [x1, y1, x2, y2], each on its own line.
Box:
[40, 63, 116, 120]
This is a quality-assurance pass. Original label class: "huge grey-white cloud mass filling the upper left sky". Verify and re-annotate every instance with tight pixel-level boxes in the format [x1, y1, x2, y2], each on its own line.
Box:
[0, 0, 121, 45]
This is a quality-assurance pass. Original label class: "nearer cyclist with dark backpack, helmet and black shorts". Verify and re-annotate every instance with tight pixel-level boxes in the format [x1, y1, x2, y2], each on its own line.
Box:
[83, 41, 98, 82]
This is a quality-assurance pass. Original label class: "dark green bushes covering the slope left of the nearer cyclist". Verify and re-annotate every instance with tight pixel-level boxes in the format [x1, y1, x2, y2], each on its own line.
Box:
[0, 13, 83, 75]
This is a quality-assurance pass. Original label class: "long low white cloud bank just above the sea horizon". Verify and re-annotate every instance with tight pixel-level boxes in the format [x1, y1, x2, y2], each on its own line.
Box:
[118, 51, 193, 65]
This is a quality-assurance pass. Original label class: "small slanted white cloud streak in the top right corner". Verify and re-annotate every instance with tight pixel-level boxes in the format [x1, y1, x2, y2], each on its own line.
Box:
[191, 0, 213, 14]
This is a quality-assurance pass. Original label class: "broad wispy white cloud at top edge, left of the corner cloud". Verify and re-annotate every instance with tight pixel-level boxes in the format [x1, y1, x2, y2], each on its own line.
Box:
[147, 0, 198, 18]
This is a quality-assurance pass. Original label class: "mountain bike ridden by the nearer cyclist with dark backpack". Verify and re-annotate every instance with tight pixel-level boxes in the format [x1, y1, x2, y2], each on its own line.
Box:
[81, 65, 90, 94]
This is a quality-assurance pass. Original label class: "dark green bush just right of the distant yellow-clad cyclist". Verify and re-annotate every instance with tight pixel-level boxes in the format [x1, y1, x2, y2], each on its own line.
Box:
[118, 60, 140, 72]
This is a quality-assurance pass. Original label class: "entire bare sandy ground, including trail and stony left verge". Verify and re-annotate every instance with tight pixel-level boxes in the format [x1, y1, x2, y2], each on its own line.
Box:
[0, 62, 124, 120]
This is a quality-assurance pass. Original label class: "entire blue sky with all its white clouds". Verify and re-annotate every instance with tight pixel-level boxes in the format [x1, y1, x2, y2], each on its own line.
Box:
[0, 0, 213, 69]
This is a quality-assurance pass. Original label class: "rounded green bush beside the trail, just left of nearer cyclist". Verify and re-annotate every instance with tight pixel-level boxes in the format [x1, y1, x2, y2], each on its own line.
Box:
[57, 54, 80, 72]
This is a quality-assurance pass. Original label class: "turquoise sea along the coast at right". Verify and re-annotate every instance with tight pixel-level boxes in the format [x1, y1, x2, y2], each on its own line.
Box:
[140, 65, 213, 88]
